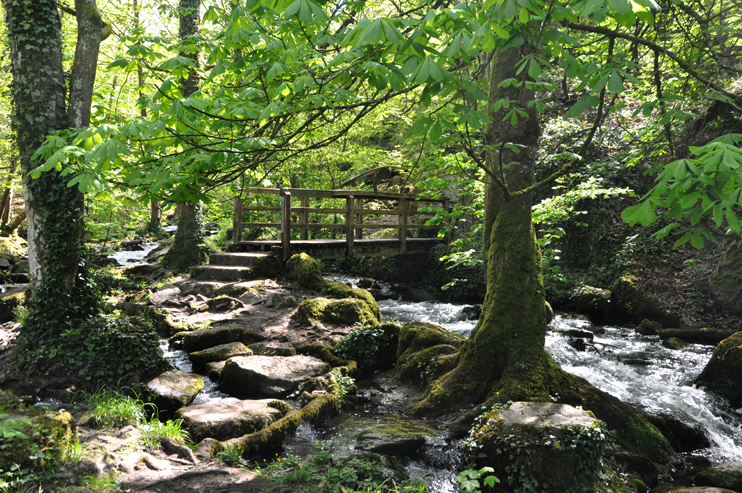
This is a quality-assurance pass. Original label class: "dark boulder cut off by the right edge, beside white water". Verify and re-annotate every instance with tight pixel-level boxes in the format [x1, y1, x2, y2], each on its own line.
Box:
[696, 332, 742, 407]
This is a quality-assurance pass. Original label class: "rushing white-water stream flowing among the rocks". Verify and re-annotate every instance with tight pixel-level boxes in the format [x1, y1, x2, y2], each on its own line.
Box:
[153, 270, 742, 493]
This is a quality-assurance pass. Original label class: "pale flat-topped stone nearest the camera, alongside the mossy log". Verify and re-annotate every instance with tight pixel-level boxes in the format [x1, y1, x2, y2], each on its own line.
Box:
[177, 397, 283, 443]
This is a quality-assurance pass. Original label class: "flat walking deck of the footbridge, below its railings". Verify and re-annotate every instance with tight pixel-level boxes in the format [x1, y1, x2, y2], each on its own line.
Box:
[230, 238, 445, 259]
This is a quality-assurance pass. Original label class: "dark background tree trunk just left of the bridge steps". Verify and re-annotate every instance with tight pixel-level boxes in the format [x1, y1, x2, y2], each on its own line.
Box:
[162, 0, 205, 271]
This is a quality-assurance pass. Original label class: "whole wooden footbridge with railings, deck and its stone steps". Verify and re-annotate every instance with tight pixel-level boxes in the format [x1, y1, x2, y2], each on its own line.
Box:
[192, 188, 448, 280]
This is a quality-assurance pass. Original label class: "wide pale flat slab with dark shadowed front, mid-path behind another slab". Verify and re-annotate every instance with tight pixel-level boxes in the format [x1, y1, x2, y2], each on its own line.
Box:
[219, 355, 330, 397]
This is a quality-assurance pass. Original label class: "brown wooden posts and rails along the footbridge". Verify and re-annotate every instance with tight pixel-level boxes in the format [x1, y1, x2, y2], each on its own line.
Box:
[234, 188, 448, 260]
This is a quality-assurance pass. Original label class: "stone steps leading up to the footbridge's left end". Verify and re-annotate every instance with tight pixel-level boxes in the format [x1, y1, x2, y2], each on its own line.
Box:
[191, 252, 281, 282]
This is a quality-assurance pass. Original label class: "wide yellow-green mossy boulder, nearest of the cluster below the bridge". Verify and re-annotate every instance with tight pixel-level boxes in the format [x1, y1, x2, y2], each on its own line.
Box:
[294, 298, 379, 326]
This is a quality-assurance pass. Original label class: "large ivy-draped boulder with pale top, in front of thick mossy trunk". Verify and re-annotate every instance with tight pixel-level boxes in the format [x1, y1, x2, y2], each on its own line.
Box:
[471, 402, 608, 493]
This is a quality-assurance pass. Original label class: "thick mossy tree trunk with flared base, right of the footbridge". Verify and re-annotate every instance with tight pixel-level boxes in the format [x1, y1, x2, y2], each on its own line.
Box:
[416, 45, 559, 413]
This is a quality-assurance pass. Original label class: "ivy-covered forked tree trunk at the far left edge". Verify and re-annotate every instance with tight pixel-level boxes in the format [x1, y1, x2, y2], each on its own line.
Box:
[2, 0, 101, 369]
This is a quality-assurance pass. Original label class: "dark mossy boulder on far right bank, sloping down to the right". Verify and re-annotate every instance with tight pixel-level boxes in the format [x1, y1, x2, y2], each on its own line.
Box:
[611, 274, 676, 325]
